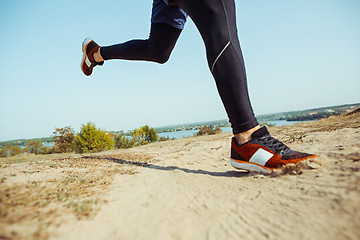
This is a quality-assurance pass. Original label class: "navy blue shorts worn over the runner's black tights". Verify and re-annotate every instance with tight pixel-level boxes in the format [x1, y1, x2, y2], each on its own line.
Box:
[151, 0, 188, 29]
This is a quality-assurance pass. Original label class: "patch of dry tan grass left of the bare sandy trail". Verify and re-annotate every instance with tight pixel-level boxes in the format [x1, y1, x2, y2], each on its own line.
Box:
[0, 155, 142, 239]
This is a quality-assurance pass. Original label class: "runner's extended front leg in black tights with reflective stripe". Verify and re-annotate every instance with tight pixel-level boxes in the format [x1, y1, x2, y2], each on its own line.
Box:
[176, 0, 258, 134]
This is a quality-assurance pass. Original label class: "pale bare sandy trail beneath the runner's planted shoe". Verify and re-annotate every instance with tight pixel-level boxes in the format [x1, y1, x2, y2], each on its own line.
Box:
[54, 116, 360, 239]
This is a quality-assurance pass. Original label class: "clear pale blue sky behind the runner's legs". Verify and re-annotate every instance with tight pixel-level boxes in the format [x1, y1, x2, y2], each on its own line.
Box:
[0, 0, 360, 141]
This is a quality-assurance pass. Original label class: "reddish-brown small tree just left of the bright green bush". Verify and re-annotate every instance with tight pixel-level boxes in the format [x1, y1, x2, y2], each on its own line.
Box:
[53, 126, 75, 152]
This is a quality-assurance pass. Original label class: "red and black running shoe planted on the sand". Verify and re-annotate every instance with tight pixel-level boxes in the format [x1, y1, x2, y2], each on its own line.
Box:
[230, 127, 316, 173]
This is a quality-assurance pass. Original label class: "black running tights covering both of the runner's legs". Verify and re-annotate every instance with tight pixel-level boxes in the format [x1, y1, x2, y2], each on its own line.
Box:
[100, 0, 258, 134]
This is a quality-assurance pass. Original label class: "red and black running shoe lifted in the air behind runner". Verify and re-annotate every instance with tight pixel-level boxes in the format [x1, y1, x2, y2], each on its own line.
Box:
[81, 38, 104, 76]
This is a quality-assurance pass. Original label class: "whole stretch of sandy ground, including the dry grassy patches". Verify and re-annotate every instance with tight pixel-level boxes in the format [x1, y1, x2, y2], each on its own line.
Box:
[0, 113, 360, 240]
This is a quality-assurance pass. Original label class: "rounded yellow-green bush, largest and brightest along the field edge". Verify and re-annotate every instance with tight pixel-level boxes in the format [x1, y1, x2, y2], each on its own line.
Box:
[74, 122, 114, 153]
